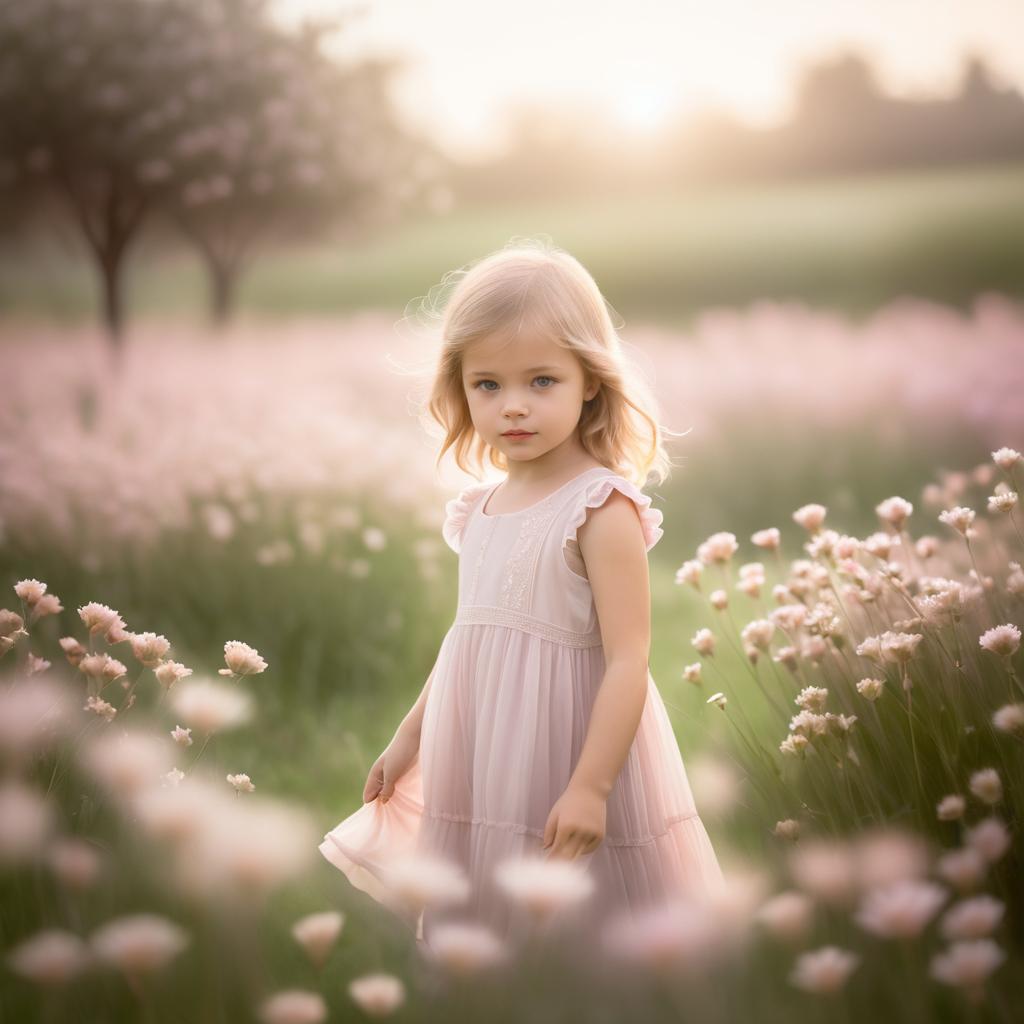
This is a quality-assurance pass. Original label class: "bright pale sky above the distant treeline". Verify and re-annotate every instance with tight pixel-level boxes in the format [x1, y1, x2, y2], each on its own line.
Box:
[272, 0, 1024, 159]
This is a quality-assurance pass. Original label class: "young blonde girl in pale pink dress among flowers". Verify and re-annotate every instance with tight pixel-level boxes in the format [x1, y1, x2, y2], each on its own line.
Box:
[319, 237, 722, 941]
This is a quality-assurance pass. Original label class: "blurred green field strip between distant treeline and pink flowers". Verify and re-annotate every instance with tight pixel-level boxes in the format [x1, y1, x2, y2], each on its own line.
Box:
[6, 158, 1024, 325]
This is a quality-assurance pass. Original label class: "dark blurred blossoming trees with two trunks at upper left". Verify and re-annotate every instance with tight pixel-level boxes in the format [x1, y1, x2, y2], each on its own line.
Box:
[0, 0, 440, 354]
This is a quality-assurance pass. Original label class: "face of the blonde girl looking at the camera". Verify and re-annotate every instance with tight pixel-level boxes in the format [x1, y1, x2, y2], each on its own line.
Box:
[462, 332, 599, 462]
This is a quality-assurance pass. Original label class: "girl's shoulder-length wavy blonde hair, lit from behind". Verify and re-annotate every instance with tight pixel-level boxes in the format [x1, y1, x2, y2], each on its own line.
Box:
[409, 239, 671, 486]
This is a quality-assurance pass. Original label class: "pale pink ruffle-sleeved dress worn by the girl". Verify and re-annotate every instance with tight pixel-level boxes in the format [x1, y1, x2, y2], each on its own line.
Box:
[319, 466, 722, 939]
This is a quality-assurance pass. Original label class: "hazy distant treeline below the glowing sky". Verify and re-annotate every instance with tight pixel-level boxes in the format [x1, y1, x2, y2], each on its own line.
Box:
[452, 53, 1024, 200]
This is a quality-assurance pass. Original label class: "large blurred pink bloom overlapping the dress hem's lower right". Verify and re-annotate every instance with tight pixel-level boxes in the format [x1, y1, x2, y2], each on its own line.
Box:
[601, 898, 725, 976]
